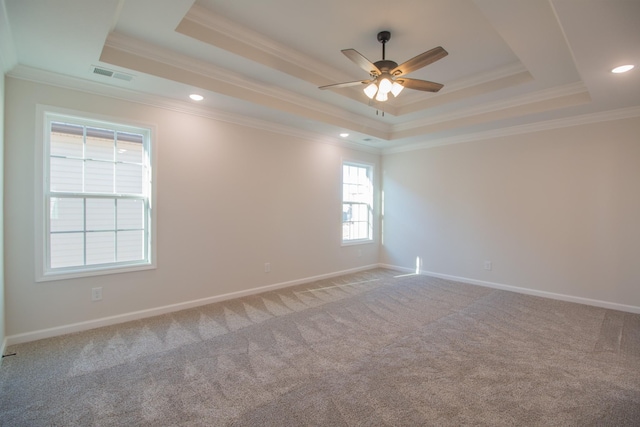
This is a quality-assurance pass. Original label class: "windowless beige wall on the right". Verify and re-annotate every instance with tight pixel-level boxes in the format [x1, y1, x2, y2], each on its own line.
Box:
[381, 118, 640, 312]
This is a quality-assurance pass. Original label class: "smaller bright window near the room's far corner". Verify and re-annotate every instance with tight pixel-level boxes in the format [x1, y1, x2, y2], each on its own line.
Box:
[342, 162, 373, 243]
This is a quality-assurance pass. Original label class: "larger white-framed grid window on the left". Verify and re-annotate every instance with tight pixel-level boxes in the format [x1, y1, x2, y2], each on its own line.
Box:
[39, 113, 153, 280]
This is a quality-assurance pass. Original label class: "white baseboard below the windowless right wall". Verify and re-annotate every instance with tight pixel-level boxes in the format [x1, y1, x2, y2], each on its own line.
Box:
[378, 264, 640, 314]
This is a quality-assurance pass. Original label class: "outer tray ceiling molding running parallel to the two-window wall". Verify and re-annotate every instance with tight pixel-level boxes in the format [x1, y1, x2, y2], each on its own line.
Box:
[105, 33, 391, 139]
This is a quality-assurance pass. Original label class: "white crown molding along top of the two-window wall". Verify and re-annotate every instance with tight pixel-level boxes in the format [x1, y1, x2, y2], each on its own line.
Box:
[7, 65, 381, 154]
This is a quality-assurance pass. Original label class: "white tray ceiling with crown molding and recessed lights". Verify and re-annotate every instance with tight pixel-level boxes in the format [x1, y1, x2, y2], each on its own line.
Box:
[0, 0, 640, 152]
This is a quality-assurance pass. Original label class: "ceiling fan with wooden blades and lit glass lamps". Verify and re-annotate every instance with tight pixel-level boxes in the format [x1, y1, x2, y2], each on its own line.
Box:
[319, 31, 449, 102]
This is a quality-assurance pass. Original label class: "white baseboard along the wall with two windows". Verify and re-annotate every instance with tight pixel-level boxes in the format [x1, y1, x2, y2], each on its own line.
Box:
[2, 264, 378, 350]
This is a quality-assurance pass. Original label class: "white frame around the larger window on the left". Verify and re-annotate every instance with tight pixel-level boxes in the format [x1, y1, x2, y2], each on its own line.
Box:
[34, 105, 156, 282]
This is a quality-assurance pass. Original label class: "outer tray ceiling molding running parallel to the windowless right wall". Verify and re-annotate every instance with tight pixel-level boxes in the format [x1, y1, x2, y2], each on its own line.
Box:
[393, 82, 588, 133]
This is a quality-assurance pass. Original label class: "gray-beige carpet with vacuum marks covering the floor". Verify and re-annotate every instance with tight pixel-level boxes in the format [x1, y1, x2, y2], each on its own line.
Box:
[0, 269, 640, 426]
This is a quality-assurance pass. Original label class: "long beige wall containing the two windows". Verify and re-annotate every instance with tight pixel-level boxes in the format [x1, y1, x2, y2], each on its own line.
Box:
[5, 78, 379, 339]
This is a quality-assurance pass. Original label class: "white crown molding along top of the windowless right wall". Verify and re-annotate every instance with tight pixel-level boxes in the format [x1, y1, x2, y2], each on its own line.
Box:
[382, 107, 640, 155]
